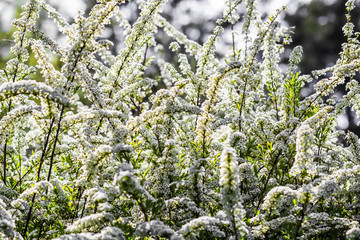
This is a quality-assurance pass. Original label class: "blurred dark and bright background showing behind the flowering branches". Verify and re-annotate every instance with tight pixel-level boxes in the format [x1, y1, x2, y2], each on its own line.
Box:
[0, 0, 360, 135]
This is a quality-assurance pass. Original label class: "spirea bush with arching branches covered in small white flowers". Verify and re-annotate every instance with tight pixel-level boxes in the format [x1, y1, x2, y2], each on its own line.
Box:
[0, 0, 360, 240]
